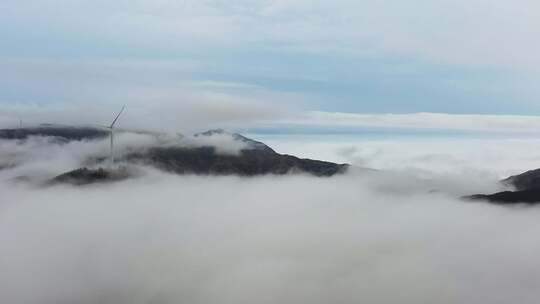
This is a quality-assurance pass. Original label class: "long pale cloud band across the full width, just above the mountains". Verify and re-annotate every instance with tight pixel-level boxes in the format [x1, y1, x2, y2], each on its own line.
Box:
[7, 103, 540, 135]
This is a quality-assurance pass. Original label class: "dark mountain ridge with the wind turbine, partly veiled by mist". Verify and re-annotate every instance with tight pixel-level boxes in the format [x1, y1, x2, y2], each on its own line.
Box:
[0, 126, 349, 185]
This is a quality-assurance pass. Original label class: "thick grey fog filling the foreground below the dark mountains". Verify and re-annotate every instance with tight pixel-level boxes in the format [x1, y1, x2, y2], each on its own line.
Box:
[0, 170, 540, 304]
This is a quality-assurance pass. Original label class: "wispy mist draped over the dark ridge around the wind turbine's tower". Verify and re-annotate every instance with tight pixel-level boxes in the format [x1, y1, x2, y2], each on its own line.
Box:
[0, 131, 262, 184]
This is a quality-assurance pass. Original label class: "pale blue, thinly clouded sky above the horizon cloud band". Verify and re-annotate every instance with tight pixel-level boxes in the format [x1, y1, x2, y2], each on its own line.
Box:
[0, 0, 540, 114]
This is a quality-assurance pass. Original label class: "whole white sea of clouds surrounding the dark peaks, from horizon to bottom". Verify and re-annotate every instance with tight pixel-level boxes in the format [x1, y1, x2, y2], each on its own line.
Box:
[0, 131, 540, 304]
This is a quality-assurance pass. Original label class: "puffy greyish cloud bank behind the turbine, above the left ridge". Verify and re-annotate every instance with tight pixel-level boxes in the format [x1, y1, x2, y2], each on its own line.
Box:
[0, 91, 288, 132]
